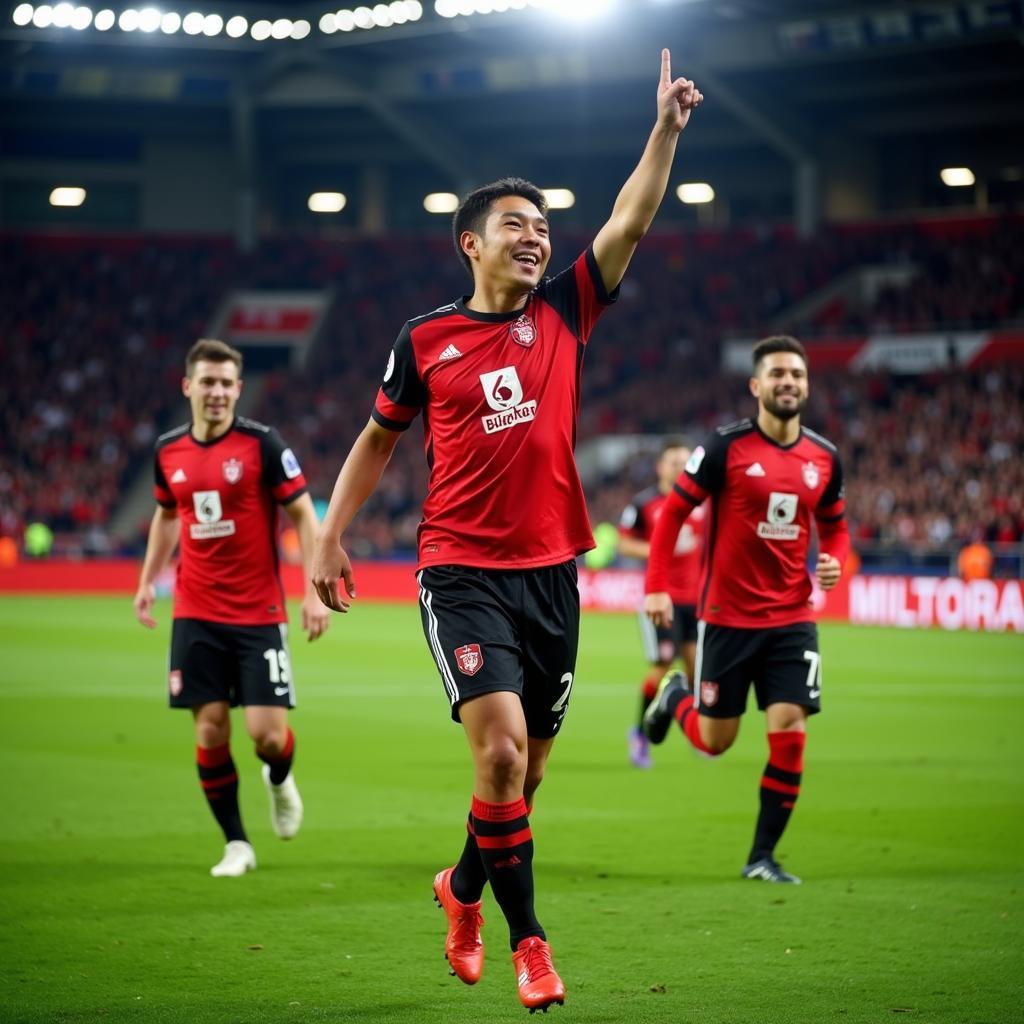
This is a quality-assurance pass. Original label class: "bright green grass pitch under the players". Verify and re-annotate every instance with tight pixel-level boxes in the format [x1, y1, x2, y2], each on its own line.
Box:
[0, 598, 1024, 1024]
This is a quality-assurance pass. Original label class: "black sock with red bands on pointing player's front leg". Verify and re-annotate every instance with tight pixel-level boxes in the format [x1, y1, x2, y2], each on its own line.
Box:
[473, 797, 545, 950]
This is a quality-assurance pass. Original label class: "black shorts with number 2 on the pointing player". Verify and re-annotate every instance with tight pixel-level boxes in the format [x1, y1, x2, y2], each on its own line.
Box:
[417, 560, 580, 739]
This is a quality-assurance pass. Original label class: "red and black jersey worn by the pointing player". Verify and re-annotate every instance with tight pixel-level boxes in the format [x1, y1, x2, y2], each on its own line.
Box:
[373, 249, 614, 568]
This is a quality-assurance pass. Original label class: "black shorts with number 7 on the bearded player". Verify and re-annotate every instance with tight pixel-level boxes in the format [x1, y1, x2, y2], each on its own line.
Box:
[695, 623, 821, 718]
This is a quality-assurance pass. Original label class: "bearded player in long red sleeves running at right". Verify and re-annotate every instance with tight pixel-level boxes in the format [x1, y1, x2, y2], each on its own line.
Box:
[644, 337, 850, 883]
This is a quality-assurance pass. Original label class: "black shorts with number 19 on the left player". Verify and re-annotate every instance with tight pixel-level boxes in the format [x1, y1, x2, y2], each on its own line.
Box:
[167, 618, 295, 708]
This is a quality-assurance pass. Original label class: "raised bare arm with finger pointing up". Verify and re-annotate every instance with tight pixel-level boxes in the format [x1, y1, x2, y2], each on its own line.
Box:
[594, 50, 703, 292]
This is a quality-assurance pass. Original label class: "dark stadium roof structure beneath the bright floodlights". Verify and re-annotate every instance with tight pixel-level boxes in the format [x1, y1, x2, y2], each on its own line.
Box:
[0, 0, 1024, 209]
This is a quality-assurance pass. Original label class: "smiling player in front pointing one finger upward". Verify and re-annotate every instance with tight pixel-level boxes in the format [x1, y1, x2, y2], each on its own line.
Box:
[313, 50, 701, 1010]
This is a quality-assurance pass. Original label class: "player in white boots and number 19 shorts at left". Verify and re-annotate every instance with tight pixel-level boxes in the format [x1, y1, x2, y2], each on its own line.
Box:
[134, 339, 330, 876]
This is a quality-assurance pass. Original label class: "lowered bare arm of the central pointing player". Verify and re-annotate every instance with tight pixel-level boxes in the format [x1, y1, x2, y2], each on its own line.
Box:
[311, 420, 401, 611]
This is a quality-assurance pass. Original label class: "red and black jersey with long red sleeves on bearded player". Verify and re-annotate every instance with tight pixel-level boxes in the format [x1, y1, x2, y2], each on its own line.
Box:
[646, 420, 849, 629]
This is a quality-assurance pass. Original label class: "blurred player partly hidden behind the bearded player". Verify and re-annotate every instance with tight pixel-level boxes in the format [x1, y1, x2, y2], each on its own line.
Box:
[618, 437, 705, 768]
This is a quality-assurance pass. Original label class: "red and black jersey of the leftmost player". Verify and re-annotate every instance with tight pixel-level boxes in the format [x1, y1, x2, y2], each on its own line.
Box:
[149, 417, 306, 626]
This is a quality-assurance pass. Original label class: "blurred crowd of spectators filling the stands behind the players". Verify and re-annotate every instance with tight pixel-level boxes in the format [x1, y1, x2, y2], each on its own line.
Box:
[0, 220, 1024, 555]
